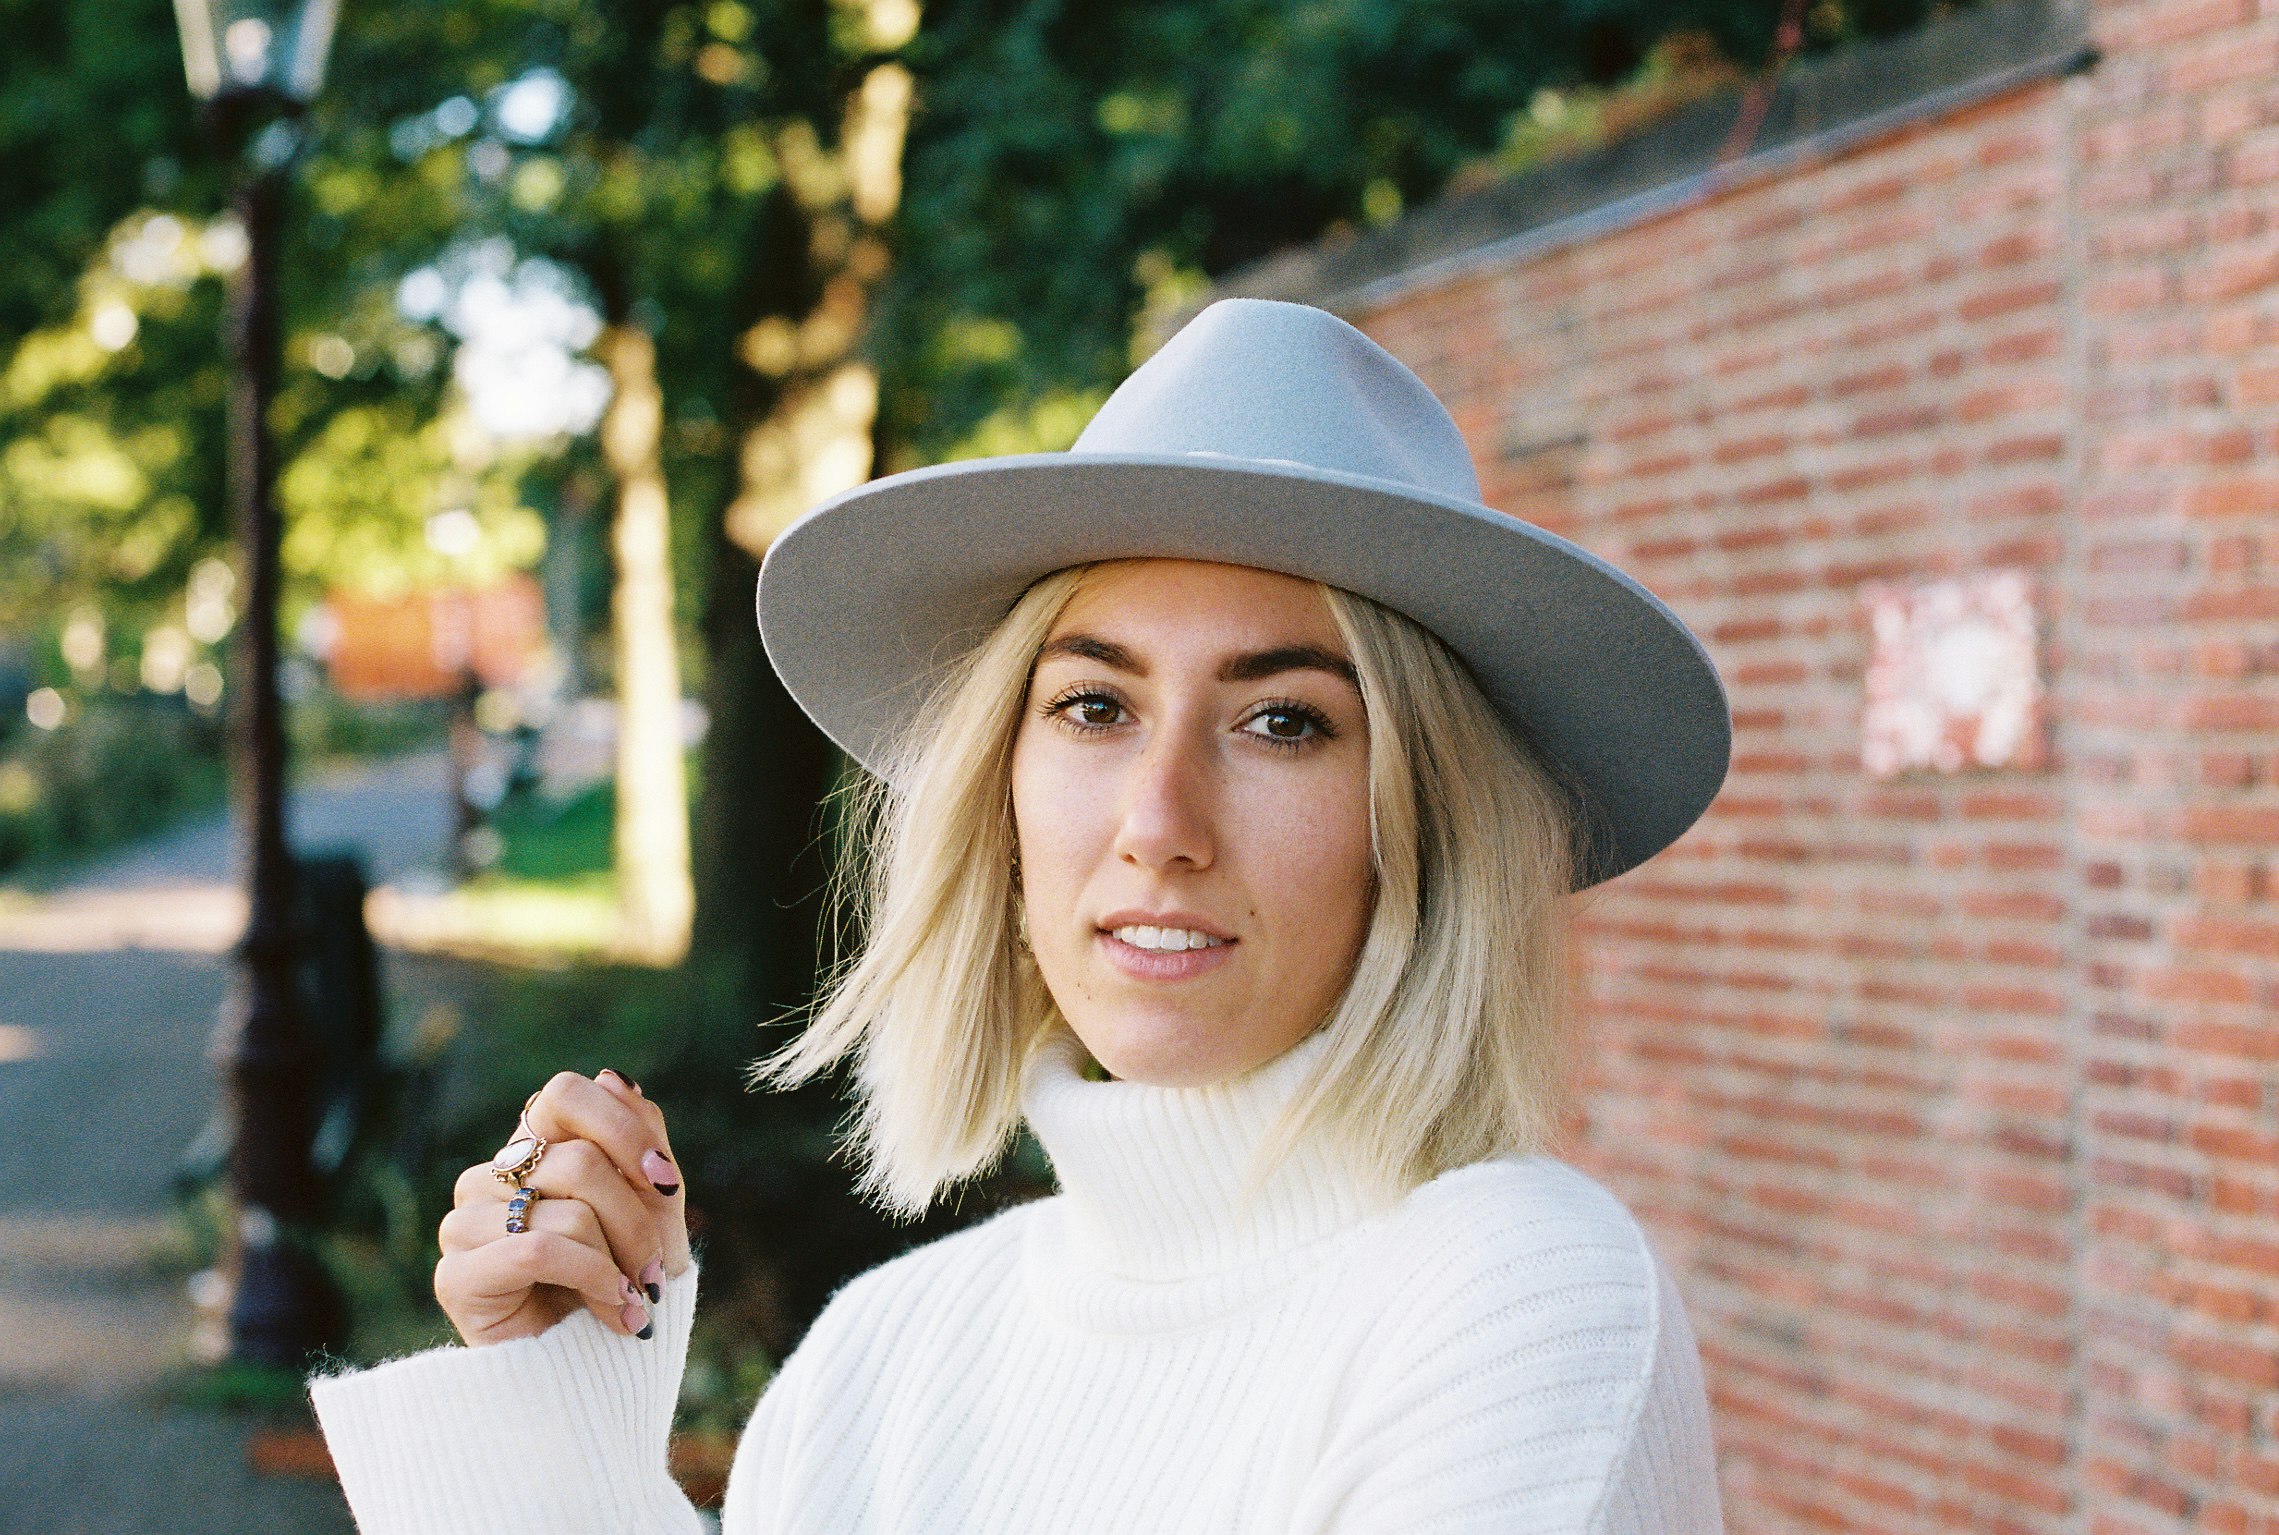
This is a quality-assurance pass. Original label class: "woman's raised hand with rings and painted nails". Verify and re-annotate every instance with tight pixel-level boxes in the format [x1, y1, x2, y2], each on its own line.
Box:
[435, 1068, 688, 1346]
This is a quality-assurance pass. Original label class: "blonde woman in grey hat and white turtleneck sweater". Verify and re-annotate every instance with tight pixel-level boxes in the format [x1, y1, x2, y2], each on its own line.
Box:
[310, 298, 1730, 1535]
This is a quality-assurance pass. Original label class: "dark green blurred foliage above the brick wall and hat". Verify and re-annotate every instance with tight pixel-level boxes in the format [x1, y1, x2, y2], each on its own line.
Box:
[877, 0, 1978, 469]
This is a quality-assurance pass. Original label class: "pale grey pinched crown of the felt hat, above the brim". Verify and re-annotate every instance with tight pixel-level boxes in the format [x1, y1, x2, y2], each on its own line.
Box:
[1069, 298, 1481, 503]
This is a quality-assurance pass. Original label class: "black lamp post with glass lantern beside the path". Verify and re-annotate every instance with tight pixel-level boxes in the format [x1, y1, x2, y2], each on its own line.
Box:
[173, 0, 342, 1366]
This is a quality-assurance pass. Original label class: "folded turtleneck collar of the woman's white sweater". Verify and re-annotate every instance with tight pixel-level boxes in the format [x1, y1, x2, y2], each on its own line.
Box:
[1021, 1025, 1370, 1298]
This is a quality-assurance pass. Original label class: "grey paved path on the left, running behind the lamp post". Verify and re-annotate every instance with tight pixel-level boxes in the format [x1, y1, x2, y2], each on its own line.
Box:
[0, 756, 471, 1535]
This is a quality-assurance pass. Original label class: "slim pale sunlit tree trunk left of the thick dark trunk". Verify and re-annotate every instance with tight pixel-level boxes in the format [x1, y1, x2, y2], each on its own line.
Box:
[599, 314, 695, 966]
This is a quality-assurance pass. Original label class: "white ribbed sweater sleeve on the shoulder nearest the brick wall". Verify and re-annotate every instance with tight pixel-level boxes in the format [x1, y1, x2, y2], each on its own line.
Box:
[1299, 1187, 1723, 1535]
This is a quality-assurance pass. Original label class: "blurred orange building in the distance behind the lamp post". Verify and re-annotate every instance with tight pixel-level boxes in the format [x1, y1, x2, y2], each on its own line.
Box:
[324, 572, 547, 699]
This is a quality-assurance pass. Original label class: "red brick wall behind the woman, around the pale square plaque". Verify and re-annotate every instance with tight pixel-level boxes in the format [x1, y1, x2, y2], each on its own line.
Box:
[1247, 0, 2279, 1535]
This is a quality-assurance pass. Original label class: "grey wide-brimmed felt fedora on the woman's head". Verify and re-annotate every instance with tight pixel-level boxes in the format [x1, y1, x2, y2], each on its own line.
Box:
[757, 298, 1732, 888]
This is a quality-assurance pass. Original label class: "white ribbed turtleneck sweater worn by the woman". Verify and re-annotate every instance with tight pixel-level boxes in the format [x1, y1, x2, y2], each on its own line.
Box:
[310, 1015, 1723, 1535]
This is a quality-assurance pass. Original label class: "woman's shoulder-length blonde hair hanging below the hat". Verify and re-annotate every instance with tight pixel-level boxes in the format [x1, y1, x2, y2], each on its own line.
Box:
[750, 565, 1582, 1216]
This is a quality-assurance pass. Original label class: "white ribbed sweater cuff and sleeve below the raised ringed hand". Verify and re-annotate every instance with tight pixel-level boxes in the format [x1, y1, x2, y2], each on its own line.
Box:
[308, 1262, 706, 1535]
